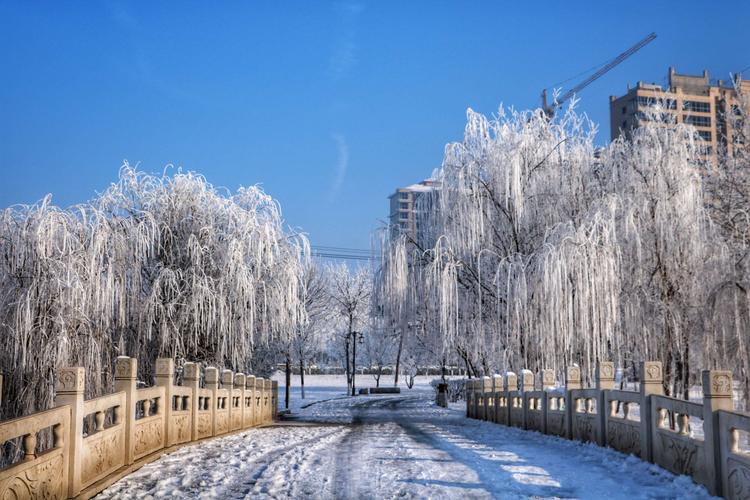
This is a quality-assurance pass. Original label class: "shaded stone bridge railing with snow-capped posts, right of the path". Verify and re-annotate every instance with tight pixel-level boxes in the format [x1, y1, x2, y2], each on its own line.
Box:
[466, 361, 750, 499]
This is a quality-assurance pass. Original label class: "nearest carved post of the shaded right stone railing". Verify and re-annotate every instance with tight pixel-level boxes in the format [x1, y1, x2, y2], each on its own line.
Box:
[701, 370, 734, 495]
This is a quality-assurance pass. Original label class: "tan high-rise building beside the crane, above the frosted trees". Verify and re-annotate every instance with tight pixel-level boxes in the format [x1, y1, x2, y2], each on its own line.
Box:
[609, 68, 750, 159]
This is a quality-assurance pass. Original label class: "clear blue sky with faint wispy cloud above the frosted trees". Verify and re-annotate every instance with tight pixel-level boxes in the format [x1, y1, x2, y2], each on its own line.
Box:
[0, 0, 750, 248]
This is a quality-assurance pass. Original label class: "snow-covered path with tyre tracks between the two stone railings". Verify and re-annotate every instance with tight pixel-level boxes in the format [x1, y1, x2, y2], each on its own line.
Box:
[98, 394, 708, 500]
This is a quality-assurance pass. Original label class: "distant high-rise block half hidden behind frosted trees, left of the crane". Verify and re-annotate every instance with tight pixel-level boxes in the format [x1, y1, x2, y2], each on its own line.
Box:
[388, 179, 438, 246]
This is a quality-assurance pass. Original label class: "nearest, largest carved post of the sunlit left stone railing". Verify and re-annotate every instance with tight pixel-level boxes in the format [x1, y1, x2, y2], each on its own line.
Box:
[55, 366, 86, 497]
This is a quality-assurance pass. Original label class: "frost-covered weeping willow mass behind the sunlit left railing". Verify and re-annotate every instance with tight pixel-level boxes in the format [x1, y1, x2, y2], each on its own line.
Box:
[0, 163, 306, 416]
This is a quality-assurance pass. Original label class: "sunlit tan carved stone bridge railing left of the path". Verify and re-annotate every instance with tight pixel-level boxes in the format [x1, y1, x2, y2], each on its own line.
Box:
[0, 356, 278, 499]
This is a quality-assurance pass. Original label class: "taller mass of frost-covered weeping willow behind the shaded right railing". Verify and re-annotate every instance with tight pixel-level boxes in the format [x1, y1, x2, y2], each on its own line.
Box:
[376, 102, 748, 402]
